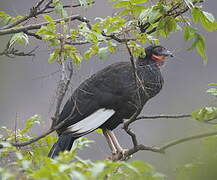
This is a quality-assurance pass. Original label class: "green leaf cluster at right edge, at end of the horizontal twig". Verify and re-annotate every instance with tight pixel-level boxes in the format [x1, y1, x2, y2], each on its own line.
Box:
[191, 107, 217, 122]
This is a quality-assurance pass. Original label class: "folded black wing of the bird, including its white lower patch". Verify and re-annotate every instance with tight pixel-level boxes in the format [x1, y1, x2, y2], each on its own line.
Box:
[58, 64, 132, 136]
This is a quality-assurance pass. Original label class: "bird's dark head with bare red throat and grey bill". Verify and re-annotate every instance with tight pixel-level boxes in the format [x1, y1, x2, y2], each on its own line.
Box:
[145, 45, 173, 66]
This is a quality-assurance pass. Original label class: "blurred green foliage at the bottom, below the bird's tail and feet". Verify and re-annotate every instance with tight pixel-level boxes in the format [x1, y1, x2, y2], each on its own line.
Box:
[0, 115, 164, 180]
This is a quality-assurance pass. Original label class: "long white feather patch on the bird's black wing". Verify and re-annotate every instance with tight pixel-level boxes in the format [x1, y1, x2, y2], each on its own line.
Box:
[64, 108, 115, 136]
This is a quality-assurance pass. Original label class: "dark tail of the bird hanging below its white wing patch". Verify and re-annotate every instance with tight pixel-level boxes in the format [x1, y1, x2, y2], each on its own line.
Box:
[48, 135, 76, 158]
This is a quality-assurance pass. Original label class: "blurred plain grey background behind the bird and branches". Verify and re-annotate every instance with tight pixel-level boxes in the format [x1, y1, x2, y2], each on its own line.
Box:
[0, 0, 217, 177]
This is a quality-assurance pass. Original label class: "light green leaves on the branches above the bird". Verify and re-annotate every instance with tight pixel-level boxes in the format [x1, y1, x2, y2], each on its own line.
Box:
[0, 0, 217, 65]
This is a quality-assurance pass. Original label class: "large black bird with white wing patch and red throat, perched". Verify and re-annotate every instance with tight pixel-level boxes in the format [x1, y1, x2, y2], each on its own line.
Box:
[48, 45, 173, 158]
